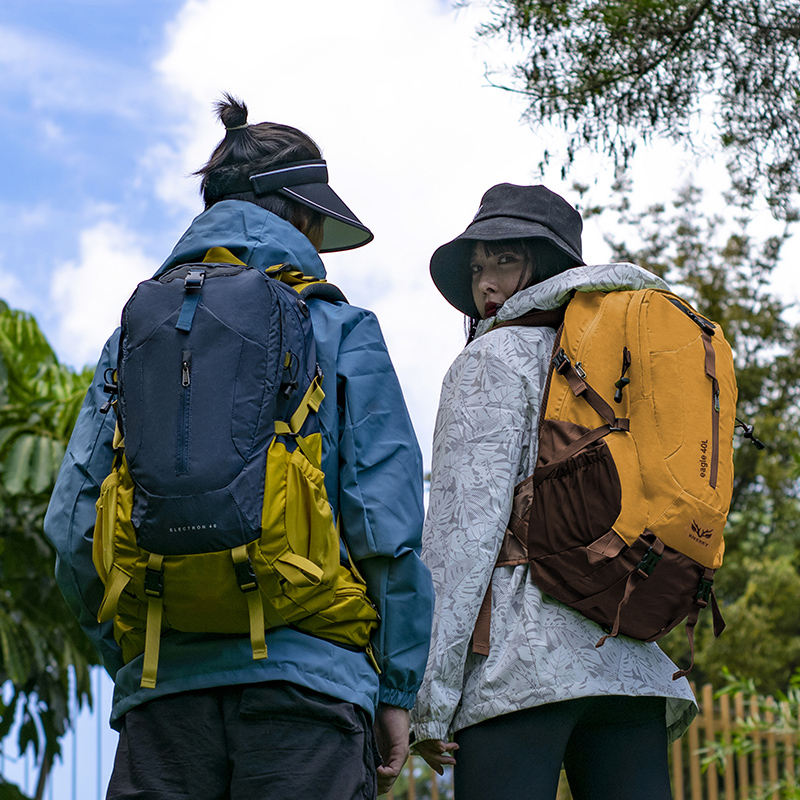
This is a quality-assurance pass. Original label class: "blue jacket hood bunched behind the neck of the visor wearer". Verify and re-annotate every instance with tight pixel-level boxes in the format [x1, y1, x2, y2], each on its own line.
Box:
[156, 200, 325, 279]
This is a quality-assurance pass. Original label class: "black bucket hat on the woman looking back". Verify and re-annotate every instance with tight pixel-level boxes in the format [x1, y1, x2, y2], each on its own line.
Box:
[431, 183, 584, 318]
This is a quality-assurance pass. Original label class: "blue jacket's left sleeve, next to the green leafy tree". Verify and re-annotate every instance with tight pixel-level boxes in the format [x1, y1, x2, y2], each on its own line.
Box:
[44, 331, 122, 677]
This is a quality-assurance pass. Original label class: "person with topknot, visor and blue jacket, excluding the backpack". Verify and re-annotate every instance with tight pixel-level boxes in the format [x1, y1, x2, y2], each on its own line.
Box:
[45, 95, 433, 800]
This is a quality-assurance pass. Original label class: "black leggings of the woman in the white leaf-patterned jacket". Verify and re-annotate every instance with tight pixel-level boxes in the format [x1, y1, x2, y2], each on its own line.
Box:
[454, 696, 672, 800]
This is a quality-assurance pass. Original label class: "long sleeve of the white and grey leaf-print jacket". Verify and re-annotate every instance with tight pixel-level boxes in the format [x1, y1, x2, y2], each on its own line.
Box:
[413, 331, 547, 740]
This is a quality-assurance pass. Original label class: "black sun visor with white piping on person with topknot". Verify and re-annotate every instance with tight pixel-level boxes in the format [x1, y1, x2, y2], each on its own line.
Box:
[217, 158, 374, 253]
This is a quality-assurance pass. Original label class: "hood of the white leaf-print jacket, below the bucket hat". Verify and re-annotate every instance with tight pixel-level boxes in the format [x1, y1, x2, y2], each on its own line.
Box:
[476, 262, 669, 336]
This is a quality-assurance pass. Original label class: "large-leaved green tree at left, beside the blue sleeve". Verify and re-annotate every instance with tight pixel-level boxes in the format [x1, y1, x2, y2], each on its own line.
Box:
[0, 301, 97, 800]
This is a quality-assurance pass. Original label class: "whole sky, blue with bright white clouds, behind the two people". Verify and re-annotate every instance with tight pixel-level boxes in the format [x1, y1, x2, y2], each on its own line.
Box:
[0, 0, 800, 796]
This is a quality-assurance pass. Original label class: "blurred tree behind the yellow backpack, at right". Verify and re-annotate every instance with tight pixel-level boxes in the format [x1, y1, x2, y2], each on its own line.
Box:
[578, 181, 800, 692]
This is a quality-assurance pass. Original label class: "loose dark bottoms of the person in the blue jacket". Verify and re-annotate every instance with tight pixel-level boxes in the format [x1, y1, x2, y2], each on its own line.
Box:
[107, 682, 380, 800]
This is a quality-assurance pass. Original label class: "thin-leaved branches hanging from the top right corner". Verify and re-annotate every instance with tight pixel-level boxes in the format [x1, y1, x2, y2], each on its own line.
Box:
[472, 0, 800, 215]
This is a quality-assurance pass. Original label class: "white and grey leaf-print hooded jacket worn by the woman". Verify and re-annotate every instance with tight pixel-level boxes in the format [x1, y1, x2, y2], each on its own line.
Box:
[412, 264, 697, 741]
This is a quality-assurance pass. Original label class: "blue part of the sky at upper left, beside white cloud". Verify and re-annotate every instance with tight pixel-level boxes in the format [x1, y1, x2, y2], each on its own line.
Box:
[0, 0, 180, 354]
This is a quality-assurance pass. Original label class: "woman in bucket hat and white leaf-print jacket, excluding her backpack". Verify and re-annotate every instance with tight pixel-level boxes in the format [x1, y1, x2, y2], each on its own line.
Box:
[412, 184, 697, 800]
